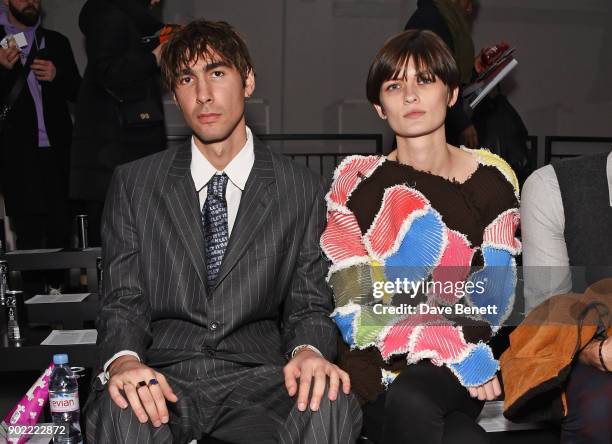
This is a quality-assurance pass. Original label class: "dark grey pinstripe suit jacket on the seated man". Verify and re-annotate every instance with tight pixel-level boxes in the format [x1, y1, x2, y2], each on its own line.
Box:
[97, 141, 337, 374]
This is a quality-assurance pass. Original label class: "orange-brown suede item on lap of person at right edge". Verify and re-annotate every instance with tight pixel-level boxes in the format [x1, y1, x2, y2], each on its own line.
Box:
[500, 279, 612, 422]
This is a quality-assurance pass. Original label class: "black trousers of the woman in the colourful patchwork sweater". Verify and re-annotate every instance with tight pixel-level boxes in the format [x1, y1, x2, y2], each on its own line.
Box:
[363, 360, 489, 444]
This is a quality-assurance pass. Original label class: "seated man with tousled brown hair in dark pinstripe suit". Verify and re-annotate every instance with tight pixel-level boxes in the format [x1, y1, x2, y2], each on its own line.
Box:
[86, 20, 361, 443]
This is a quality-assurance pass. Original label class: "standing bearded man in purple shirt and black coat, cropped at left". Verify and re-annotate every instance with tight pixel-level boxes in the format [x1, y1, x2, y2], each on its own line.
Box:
[0, 0, 81, 249]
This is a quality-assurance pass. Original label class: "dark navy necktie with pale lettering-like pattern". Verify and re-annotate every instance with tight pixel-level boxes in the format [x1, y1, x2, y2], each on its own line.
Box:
[202, 173, 229, 287]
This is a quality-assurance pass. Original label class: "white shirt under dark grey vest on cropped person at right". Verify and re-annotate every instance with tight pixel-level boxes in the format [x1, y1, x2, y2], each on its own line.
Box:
[521, 152, 612, 313]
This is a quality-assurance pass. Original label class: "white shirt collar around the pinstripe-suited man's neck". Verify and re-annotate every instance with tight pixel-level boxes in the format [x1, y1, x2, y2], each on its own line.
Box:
[190, 127, 255, 191]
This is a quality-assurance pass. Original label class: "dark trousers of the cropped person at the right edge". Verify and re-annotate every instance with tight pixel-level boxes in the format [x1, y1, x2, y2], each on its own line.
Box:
[561, 363, 612, 444]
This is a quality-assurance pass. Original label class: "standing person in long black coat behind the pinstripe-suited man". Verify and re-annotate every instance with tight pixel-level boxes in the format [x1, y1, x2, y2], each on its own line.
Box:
[70, 0, 166, 246]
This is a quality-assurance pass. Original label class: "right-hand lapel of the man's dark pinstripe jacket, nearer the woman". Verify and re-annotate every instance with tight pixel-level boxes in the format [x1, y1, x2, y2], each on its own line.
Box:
[213, 139, 274, 289]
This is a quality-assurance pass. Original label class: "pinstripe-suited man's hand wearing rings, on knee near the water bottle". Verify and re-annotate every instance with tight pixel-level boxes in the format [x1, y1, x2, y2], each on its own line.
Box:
[108, 356, 178, 427]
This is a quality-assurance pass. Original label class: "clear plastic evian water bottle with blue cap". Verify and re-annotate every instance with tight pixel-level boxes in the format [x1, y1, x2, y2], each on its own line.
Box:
[49, 354, 83, 444]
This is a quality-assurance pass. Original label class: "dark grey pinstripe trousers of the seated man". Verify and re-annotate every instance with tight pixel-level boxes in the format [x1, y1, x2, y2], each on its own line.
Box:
[85, 358, 361, 444]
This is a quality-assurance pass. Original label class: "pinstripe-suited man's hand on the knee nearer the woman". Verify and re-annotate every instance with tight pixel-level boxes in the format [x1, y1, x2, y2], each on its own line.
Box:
[283, 349, 351, 412]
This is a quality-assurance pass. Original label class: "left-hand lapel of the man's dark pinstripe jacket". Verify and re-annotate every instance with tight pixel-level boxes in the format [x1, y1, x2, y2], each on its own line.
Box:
[162, 143, 206, 289]
